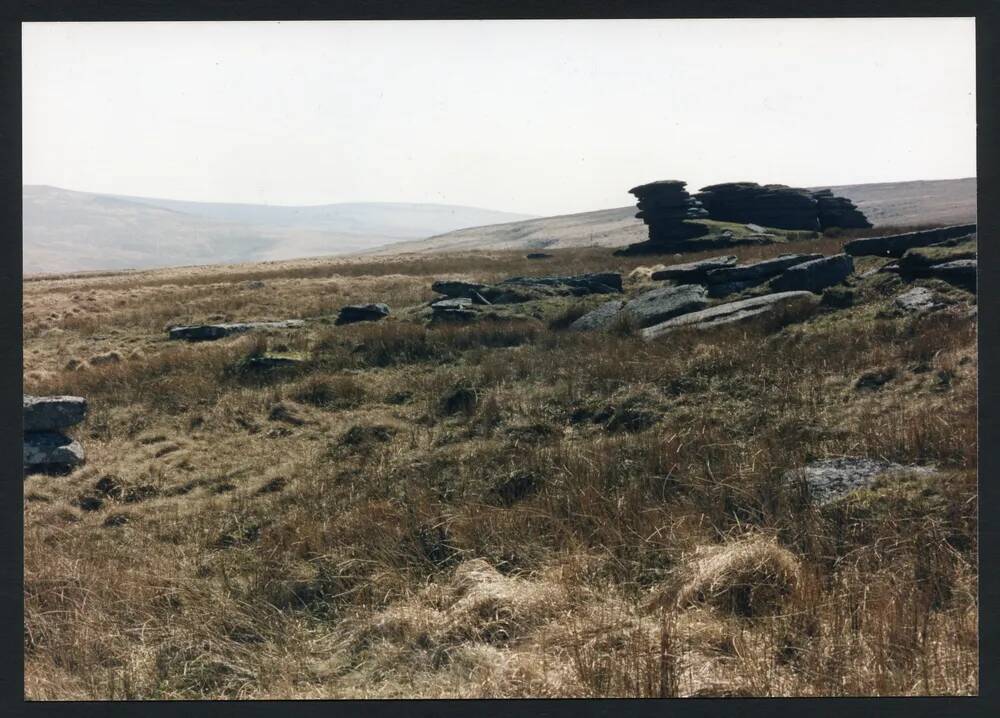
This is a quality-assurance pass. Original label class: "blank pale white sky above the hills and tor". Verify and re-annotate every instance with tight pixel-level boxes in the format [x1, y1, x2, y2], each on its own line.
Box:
[23, 18, 976, 215]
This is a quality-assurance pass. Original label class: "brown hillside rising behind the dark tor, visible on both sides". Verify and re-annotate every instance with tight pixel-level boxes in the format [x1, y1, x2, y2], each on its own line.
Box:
[370, 177, 976, 254]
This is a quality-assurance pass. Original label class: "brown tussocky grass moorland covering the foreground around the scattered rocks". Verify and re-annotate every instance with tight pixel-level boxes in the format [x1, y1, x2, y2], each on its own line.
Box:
[24, 228, 978, 699]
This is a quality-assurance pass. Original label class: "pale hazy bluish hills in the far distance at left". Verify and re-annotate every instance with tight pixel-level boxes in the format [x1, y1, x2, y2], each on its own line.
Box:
[22, 185, 530, 274]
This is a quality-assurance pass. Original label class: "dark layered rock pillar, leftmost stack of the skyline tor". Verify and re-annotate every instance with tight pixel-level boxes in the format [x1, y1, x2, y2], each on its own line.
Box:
[629, 180, 708, 251]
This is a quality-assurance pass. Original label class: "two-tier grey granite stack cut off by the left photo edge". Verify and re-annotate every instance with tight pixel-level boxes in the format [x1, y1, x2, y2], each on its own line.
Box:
[24, 394, 87, 472]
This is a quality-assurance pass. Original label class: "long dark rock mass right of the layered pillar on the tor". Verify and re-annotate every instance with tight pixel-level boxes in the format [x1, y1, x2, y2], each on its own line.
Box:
[697, 182, 820, 231]
